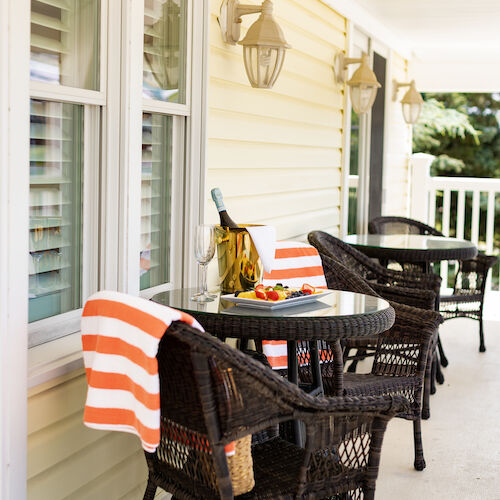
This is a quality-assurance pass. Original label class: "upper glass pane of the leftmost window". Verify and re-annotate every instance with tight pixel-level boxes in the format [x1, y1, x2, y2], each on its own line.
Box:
[30, 0, 100, 90]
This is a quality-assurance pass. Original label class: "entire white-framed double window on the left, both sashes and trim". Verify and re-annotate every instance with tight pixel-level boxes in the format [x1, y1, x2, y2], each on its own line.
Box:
[28, 0, 199, 346]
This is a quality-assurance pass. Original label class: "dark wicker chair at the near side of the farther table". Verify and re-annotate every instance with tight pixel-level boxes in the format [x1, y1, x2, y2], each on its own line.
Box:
[308, 231, 441, 419]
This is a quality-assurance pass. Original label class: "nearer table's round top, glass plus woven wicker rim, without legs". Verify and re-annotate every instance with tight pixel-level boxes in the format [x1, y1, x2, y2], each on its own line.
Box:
[151, 289, 394, 340]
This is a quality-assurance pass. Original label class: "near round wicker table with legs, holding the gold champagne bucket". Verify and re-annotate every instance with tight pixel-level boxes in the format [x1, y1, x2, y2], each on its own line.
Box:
[151, 289, 395, 446]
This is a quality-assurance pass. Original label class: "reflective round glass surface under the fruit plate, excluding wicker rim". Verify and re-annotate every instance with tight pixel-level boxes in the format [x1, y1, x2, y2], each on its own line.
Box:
[151, 288, 391, 318]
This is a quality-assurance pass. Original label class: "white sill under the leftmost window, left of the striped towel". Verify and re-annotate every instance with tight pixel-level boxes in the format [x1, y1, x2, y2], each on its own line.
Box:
[28, 332, 83, 389]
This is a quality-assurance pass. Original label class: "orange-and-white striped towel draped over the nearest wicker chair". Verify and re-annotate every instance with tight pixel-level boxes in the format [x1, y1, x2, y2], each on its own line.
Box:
[81, 291, 234, 455]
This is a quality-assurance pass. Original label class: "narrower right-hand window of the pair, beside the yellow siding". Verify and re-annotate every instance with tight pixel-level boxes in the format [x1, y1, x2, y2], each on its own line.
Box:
[140, 0, 191, 296]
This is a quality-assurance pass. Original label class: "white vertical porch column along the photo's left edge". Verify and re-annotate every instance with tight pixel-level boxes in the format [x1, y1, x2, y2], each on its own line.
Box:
[0, 0, 30, 500]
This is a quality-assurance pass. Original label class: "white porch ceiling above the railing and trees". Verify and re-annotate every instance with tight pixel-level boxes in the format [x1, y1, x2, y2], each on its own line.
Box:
[330, 0, 500, 92]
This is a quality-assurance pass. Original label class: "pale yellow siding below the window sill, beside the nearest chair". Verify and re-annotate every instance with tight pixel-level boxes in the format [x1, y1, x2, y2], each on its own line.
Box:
[28, 370, 147, 500]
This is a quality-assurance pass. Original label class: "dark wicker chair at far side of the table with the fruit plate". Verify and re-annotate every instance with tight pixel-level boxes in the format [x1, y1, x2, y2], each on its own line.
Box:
[301, 253, 442, 470]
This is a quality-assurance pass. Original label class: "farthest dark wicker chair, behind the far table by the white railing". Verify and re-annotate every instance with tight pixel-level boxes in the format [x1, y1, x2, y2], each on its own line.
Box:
[368, 217, 498, 352]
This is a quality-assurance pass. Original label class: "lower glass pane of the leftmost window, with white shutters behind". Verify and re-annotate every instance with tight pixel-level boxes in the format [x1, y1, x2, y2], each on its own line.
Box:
[29, 100, 83, 321]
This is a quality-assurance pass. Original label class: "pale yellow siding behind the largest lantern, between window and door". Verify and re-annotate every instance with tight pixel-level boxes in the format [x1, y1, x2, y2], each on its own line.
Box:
[206, 0, 346, 240]
